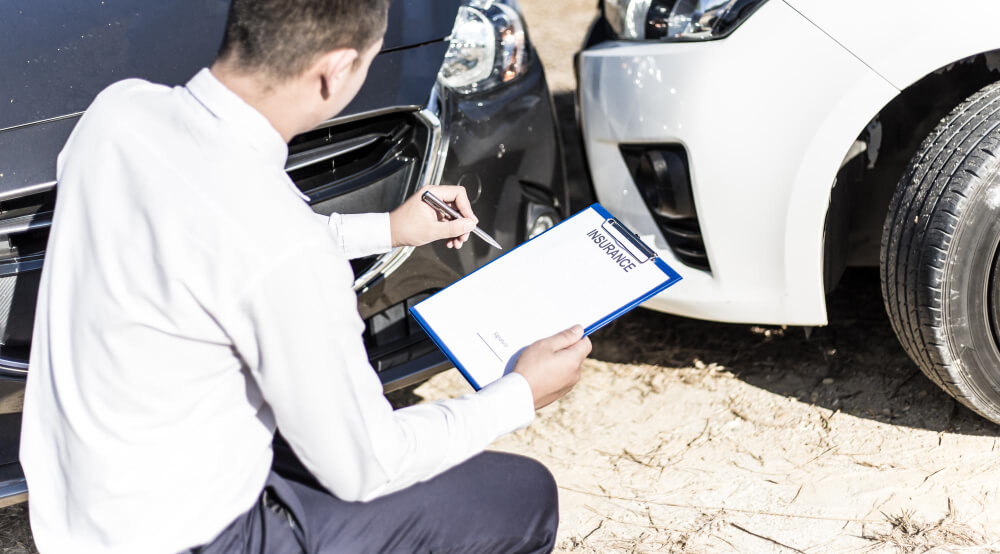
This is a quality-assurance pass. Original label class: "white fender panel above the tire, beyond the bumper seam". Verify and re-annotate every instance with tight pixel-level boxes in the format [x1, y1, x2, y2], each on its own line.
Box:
[785, 0, 1000, 89]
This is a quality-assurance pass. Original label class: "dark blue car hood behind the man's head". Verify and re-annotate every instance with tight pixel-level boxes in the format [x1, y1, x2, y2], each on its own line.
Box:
[0, 0, 459, 130]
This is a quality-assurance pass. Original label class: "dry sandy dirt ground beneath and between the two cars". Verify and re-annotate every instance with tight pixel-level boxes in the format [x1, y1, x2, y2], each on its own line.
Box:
[0, 0, 1000, 554]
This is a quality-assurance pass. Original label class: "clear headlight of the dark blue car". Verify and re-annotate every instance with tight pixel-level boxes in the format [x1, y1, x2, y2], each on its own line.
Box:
[438, 0, 529, 94]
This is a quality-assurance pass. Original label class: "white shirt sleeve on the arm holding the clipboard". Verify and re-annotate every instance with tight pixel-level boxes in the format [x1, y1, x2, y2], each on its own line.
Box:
[237, 237, 535, 501]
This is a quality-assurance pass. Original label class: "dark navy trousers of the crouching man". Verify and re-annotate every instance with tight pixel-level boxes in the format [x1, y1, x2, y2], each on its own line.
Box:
[192, 452, 559, 554]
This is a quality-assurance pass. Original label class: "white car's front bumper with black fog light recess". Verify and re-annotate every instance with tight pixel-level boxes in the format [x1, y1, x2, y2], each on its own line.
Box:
[579, 0, 898, 325]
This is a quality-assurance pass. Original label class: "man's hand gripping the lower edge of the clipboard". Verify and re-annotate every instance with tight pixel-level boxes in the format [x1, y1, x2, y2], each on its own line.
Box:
[514, 325, 591, 410]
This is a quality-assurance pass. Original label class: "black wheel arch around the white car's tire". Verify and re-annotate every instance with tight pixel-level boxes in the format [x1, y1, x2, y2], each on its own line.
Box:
[800, 48, 1000, 316]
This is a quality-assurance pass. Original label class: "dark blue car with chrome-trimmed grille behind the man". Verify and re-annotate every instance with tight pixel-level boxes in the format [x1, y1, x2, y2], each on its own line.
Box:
[0, 0, 570, 506]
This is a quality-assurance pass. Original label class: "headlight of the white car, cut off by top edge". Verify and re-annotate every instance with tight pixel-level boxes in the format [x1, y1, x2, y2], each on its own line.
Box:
[604, 0, 767, 41]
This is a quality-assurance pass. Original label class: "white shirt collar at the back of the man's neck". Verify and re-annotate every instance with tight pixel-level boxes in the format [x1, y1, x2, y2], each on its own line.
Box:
[186, 67, 288, 169]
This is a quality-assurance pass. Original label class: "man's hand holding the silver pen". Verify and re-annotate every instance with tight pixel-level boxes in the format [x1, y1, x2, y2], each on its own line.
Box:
[389, 185, 479, 248]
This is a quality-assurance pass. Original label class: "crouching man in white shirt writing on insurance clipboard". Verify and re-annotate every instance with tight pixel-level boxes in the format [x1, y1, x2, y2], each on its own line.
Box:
[21, 0, 590, 554]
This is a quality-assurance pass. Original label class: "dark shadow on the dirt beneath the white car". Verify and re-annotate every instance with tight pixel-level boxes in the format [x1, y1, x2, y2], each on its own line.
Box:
[591, 269, 1000, 436]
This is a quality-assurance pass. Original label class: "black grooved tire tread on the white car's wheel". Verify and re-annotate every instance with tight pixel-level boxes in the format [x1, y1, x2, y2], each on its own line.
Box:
[880, 83, 1000, 421]
